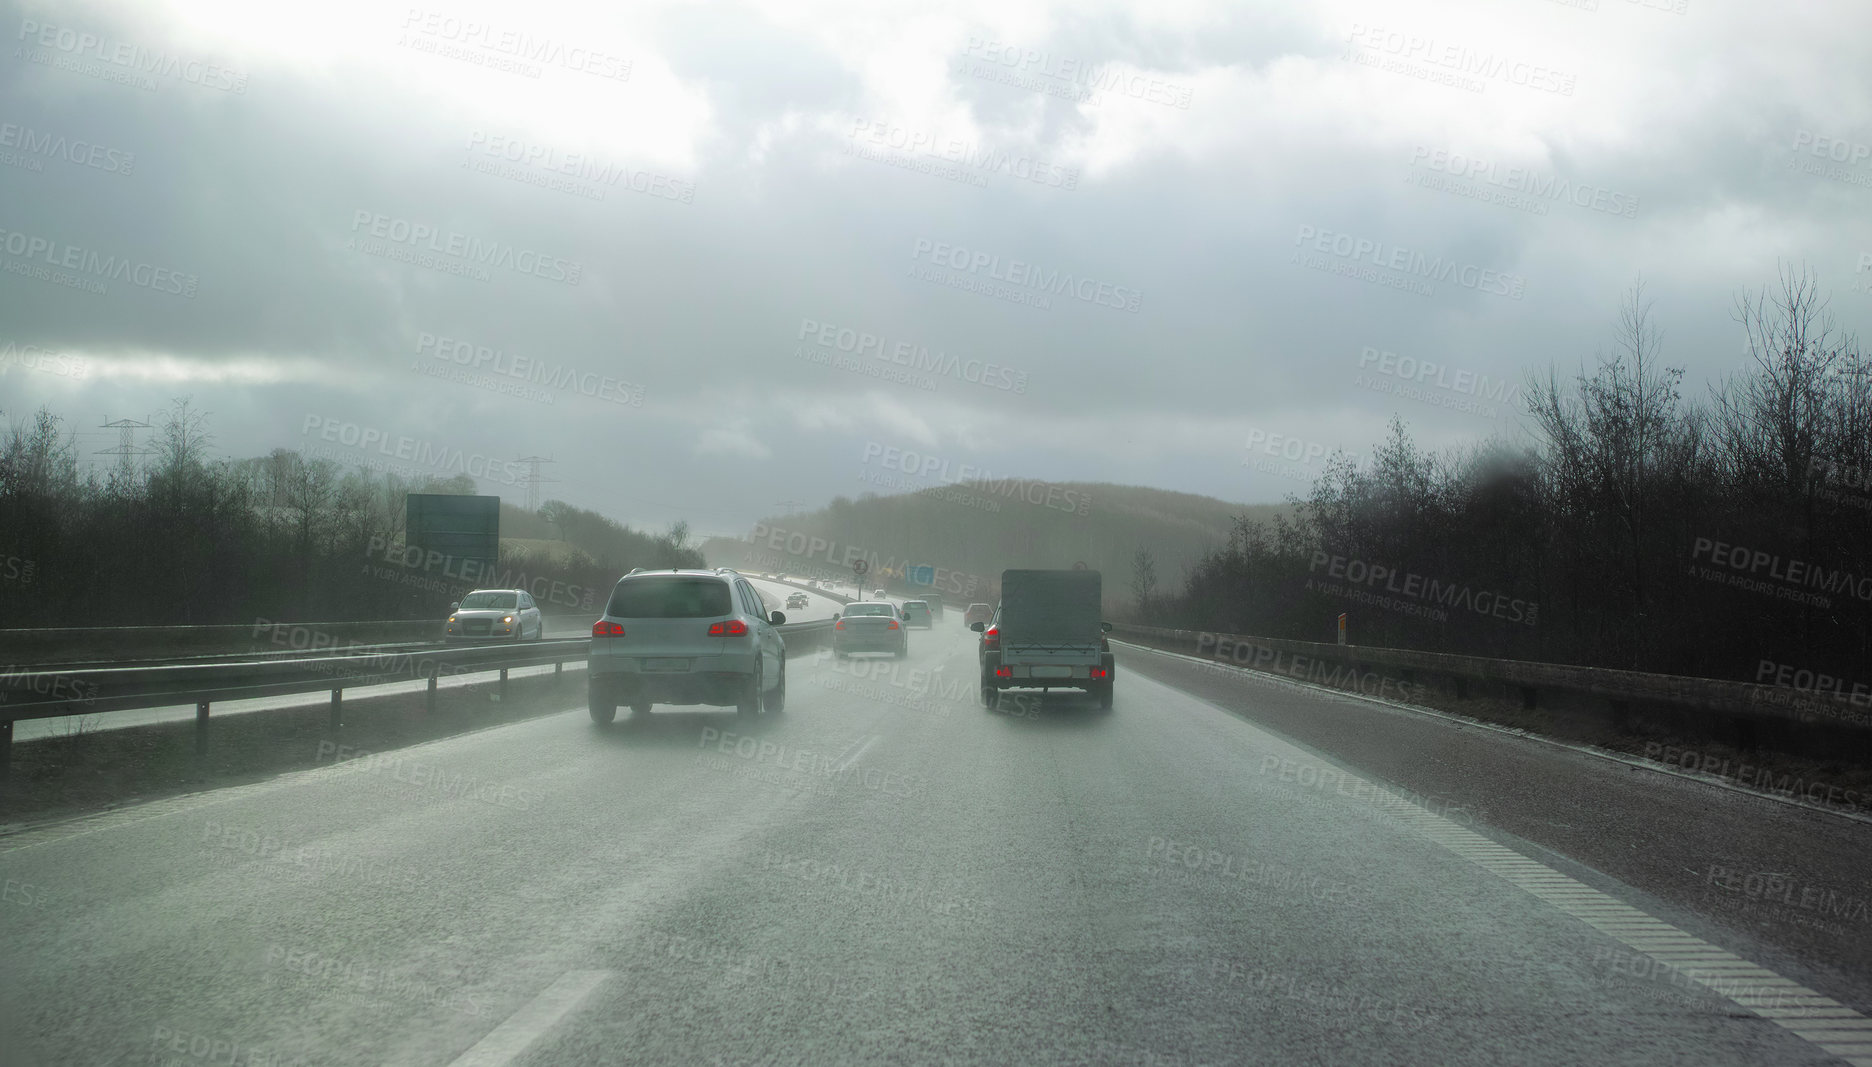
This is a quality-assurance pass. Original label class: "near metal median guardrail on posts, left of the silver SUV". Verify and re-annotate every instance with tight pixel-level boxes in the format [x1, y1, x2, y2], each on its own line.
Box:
[0, 620, 833, 777]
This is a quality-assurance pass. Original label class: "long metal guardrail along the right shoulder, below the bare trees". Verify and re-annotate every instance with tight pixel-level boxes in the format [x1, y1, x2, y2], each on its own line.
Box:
[1112, 623, 1872, 730]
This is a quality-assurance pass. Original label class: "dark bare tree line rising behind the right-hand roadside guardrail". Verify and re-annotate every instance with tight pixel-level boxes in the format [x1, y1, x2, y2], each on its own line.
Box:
[1133, 270, 1872, 683]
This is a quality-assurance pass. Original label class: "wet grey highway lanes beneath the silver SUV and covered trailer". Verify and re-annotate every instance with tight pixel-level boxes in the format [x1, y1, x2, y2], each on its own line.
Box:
[0, 618, 1865, 1067]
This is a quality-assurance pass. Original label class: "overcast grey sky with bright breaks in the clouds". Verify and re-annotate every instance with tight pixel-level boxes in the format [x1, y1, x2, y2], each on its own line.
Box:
[0, 0, 1872, 534]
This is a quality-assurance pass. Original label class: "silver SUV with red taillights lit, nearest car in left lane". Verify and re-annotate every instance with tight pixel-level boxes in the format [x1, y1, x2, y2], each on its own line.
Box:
[586, 567, 786, 726]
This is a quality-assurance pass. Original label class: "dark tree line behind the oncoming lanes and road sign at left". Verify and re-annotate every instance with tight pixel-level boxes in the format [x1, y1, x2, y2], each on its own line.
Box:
[0, 399, 702, 629]
